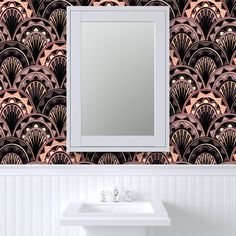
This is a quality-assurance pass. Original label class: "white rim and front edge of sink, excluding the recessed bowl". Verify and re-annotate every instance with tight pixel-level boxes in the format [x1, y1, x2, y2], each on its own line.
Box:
[61, 201, 171, 227]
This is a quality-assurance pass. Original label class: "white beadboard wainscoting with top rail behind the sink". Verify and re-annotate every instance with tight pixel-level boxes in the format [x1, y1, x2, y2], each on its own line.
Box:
[0, 165, 236, 236]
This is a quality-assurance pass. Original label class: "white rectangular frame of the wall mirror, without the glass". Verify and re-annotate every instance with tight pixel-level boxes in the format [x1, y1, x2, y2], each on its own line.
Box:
[67, 6, 169, 152]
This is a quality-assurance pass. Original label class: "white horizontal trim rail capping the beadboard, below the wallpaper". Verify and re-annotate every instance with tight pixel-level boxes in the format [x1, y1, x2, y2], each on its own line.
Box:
[0, 165, 236, 176]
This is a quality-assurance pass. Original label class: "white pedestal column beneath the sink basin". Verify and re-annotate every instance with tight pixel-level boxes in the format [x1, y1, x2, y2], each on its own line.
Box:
[83, 226, 148, 236]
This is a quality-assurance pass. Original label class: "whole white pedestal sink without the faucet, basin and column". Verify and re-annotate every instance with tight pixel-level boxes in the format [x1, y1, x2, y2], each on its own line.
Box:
[61, 201, 170, 236]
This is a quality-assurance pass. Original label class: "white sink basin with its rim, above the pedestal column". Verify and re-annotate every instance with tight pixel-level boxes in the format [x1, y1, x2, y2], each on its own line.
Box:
[61, 201, 170, 227]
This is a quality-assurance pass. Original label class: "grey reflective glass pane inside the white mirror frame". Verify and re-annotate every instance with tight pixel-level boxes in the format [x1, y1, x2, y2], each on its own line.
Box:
[81, 22, 155, 136]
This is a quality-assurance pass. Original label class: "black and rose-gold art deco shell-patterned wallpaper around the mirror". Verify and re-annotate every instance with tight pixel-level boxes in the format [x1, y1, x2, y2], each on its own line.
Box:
[0, 0, 236, 164]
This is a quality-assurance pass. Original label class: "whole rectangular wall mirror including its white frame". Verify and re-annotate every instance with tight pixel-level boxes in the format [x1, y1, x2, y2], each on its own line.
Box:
[67, 6, 169, 152]
